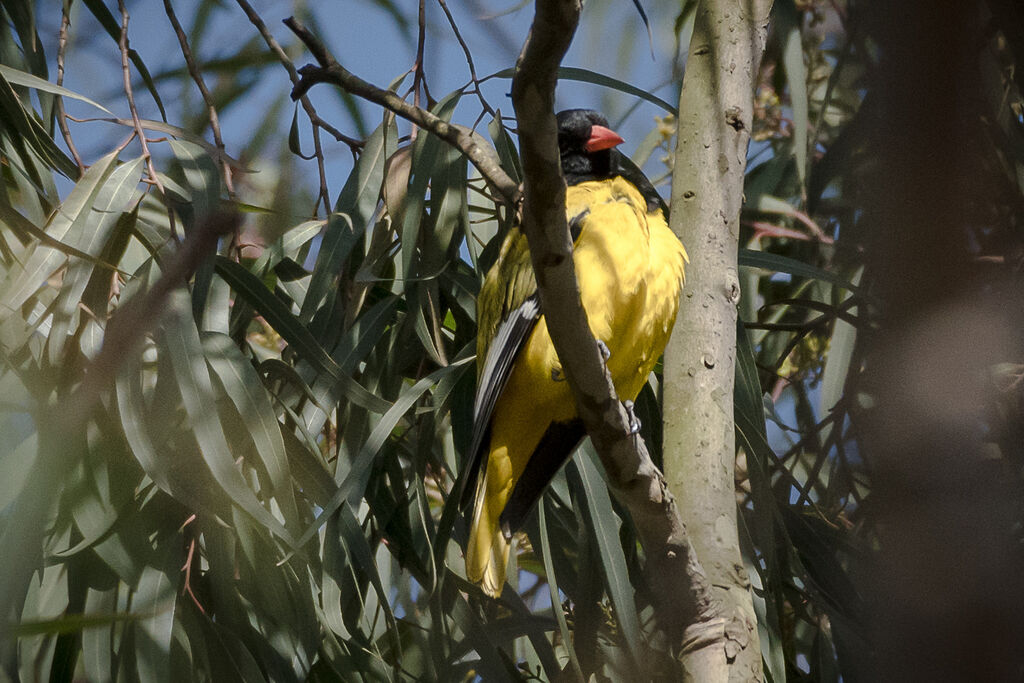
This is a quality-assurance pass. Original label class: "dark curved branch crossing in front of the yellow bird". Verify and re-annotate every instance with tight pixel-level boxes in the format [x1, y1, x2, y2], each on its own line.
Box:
[512, 0, 723, 649]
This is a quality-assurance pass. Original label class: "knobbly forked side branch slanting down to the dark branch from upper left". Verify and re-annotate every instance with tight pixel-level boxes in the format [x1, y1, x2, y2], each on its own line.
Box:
[285, 16, 521, 207]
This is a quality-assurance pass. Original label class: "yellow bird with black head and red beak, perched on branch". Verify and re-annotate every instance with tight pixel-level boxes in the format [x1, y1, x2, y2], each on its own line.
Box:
[460, 110, 687, 597]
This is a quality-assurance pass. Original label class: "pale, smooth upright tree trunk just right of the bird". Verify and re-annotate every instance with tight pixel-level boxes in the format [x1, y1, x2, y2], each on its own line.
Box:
[665, 0, 771, 683]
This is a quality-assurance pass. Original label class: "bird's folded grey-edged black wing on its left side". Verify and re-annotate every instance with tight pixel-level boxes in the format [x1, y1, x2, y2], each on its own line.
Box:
[459, 293, 541, 509]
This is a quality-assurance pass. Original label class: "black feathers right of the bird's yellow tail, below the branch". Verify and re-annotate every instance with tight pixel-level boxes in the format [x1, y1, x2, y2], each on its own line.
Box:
[498, 418, 587, 539]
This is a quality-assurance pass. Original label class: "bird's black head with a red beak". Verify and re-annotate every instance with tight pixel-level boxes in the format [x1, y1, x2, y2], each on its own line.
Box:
[555, 110, 623, 185]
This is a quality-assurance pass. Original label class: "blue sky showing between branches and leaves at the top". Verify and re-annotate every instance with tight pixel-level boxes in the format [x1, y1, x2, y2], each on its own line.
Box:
[48, 0, 679, 200]
